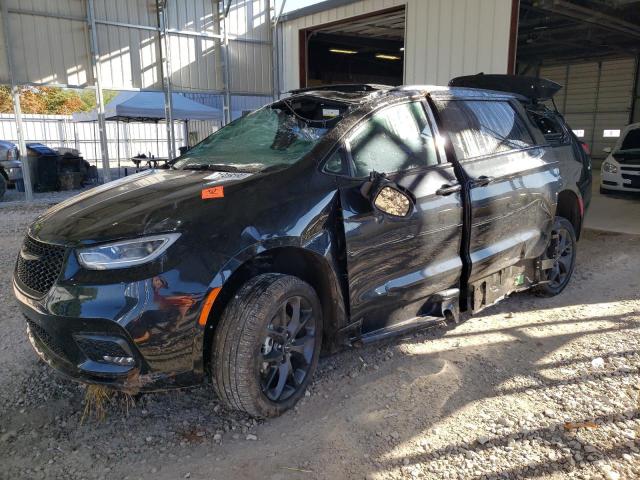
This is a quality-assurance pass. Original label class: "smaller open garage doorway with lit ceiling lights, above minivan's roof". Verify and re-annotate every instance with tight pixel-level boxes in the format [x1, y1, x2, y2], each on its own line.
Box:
[300, 7, 405, 87]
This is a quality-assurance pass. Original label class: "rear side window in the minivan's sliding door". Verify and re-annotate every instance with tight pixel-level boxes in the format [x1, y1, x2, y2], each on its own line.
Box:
[439, 100, 534, 160]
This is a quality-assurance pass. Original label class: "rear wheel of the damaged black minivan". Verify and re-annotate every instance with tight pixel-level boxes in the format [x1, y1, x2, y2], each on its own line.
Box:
[535, 217, 576, 297]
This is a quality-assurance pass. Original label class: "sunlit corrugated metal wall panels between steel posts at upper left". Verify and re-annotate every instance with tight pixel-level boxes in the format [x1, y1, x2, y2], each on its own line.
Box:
[0, 0, 272, 95]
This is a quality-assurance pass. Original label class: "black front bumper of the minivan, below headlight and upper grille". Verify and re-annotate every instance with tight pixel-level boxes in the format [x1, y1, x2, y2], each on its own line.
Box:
[14, 281, 204, 393]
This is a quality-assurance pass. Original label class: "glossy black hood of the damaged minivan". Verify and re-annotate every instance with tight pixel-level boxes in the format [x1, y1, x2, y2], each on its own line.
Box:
[29, 170, 265, 245]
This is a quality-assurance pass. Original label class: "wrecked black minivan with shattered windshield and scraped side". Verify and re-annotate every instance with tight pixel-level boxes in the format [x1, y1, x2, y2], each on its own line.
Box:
[14, 79, 590, 417]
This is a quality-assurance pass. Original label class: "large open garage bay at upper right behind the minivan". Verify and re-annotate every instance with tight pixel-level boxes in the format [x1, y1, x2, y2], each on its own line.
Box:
[516, 0, 640, 159]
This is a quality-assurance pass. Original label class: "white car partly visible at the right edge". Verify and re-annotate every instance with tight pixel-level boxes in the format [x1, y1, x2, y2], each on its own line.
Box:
[600, 123, 640, 193]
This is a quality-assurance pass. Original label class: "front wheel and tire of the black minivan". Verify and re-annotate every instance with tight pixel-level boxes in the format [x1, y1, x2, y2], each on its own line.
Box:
[211, 273, 322, 417]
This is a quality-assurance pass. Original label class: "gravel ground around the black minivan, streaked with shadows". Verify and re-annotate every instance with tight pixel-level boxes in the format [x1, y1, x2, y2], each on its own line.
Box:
[0, 205, 640, 480]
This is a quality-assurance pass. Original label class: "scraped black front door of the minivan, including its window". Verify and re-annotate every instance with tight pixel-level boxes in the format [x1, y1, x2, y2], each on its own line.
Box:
[336, 101, 462, 335]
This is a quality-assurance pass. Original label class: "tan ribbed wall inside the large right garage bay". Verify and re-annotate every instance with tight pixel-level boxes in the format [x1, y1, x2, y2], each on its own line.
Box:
[539, 58, 636, 158]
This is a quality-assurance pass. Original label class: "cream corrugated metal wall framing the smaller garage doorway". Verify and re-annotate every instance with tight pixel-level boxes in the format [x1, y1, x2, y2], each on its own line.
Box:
[279, 0, 511, 91]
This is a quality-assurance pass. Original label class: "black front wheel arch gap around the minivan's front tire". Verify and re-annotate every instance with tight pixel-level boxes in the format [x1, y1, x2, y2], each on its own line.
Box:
[203, 247, 346, 370]
